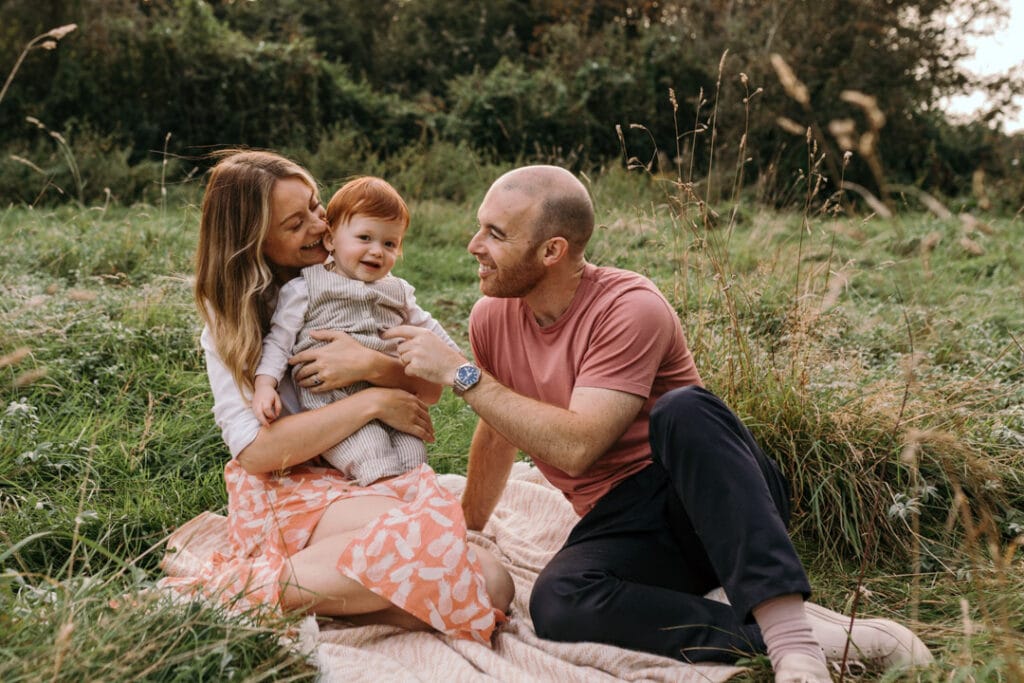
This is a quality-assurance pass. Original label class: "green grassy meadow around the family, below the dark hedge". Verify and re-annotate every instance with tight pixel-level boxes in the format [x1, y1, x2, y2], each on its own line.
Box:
[0, 171, 1024, 681]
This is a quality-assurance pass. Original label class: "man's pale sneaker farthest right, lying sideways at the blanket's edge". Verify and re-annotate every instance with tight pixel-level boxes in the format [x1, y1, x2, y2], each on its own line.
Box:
[804, 602, 934, 670]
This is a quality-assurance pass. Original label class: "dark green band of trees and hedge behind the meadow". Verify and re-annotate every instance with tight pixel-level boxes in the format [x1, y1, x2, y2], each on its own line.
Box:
[0, 0, 1022, 212]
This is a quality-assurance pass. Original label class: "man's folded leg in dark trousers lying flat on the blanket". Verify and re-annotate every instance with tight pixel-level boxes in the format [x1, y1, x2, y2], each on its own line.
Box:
[529, 465, 764, 661]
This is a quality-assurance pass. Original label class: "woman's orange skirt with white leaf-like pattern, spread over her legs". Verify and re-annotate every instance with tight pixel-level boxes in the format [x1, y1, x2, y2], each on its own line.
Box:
[160, 460, 505, 644]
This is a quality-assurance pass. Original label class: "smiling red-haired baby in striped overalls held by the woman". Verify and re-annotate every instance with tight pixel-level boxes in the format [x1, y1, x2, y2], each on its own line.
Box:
[252, 177, 458, 486]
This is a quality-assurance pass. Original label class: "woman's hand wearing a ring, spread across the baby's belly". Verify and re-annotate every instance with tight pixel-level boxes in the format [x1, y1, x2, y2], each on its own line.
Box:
[288, 330, 387, 393]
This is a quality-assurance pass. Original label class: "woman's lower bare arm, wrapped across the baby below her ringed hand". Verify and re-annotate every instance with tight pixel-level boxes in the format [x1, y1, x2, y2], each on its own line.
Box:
[238, 387, 434, 474]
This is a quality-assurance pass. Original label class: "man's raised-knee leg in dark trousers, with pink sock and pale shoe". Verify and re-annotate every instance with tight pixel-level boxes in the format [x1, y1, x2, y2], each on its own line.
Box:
[650, 387, 931, 681]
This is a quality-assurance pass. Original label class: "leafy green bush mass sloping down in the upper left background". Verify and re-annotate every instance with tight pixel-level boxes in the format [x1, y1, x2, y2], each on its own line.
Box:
[0, 0, 414, 184]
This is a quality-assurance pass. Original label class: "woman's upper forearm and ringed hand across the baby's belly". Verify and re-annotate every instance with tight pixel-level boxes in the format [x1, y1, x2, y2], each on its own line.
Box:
[288, 330, 441, 403]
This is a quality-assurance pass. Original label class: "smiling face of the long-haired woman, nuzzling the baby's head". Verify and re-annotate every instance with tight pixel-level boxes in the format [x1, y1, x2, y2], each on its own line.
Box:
[263, 177, 327, 280]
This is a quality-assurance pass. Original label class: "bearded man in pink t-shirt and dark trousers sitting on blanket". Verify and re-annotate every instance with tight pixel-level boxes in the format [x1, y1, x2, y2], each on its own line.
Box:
[386, 166, 931, 683]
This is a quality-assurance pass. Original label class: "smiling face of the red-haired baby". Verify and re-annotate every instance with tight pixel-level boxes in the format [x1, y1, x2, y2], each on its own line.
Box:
[324, 215, 406, 283]
